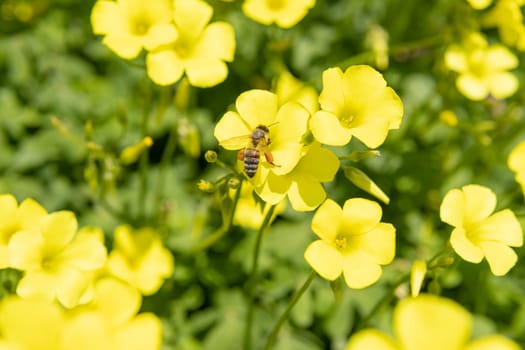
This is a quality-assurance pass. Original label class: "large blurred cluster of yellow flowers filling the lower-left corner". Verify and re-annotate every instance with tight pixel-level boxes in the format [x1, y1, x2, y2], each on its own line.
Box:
[0, 194, 173, 350]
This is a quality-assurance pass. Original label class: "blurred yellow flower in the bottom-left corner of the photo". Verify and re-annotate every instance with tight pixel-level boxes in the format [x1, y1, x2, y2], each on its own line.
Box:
[0, 295, 64, 350]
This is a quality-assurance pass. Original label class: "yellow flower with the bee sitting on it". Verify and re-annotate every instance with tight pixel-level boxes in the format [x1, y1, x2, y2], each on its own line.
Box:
[214, 90, 309, 182]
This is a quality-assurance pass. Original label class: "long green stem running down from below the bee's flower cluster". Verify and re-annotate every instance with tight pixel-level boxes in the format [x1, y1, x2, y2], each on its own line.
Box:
[243, 205, 275, 350]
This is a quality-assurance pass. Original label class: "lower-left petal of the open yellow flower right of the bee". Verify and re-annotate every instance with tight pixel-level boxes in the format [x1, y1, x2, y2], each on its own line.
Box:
[310, 111, 352, 146]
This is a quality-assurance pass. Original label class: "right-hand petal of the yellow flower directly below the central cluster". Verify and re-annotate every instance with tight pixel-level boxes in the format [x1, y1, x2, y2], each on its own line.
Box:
[359, 222, 396, 265]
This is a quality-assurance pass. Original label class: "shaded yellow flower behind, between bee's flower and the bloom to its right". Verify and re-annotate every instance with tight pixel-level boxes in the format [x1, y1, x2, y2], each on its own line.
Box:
[275, 71, 319, 114]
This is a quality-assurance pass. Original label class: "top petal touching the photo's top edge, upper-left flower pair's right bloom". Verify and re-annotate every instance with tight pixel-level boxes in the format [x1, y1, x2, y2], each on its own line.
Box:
[173, 0, 213, 37]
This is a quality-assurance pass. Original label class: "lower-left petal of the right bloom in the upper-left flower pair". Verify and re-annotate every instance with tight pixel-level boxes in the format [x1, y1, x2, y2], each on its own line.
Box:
[146, 50, 184, 85]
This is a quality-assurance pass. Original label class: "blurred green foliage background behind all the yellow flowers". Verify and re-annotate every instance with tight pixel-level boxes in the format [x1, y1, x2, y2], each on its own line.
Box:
[0, 0, 525, 349]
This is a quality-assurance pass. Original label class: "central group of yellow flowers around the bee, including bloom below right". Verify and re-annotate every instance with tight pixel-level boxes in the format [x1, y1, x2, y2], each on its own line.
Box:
[215, 65, 403, 288]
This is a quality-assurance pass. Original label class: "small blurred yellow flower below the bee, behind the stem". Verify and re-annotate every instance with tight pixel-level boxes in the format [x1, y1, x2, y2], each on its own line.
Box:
[230, 181, 286, 230]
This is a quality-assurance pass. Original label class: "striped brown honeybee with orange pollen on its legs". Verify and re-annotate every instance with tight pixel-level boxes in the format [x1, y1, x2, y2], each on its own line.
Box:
[222, 125, 279, 178]
